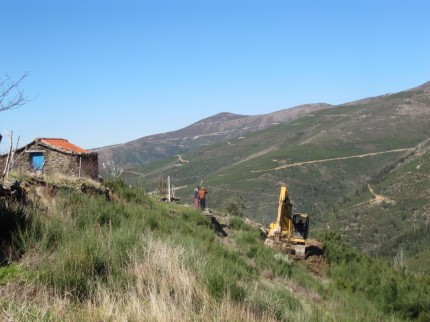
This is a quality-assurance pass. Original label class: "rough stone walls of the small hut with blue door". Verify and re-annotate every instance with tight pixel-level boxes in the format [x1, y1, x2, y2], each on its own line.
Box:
[0, 142, 98, 179]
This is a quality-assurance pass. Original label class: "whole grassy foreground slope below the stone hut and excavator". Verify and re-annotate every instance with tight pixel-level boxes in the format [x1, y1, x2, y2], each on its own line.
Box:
[0, 177, 429, 321]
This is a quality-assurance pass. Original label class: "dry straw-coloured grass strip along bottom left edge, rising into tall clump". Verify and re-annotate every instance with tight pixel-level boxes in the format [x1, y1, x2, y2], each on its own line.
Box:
[0, 236, 282, 321]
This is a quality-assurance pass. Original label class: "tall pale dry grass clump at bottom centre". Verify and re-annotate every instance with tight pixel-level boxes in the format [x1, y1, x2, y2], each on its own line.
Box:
[86, 239, 278, 321]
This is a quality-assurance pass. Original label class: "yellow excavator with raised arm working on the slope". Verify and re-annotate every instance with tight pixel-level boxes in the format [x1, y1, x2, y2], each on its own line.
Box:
[265, 185, 309, 257]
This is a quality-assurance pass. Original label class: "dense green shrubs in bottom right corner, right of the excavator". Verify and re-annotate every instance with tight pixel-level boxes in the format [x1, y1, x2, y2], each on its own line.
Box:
[321, 233, 430, 321]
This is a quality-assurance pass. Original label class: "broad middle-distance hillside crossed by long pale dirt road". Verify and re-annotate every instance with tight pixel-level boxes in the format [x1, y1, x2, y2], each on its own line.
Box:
[139, 90, 430, 223]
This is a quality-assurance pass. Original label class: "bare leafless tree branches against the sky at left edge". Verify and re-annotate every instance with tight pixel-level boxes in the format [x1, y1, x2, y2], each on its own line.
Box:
[0, 73, 28, 112]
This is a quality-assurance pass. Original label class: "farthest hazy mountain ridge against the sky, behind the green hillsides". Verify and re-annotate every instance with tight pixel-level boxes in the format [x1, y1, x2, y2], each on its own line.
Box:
[96, 104, 330, 167]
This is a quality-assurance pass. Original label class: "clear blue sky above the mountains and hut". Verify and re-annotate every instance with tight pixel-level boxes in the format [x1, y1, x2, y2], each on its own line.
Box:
[0, 0, 430, 152]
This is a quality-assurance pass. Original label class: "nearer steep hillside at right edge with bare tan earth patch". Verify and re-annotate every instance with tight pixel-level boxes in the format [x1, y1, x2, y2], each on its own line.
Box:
[326, 141, 430, 272]
